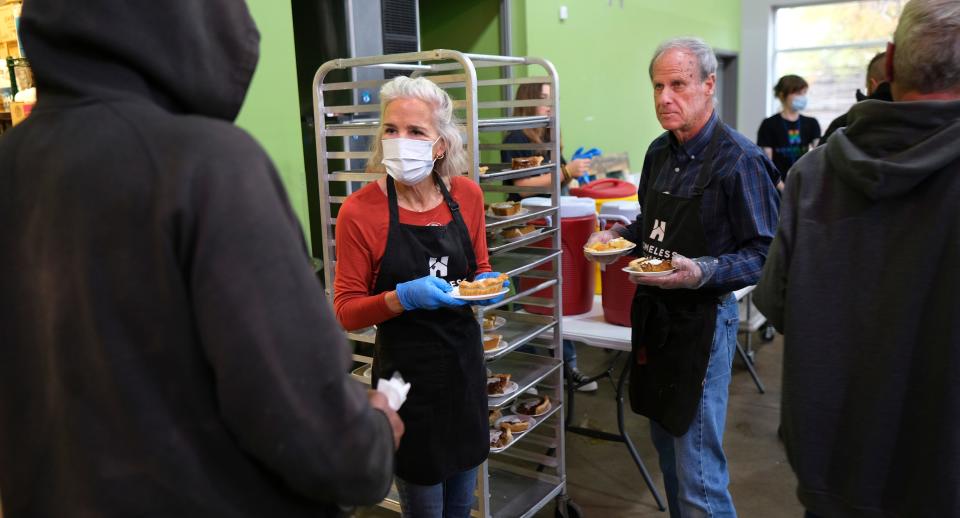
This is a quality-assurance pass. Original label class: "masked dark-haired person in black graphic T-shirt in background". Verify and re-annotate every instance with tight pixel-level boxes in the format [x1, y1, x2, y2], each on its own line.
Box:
[757, 75, 820, 189]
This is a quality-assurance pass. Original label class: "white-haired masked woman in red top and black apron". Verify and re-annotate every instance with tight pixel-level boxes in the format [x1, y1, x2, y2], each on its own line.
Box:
[334, 76, 502, 518]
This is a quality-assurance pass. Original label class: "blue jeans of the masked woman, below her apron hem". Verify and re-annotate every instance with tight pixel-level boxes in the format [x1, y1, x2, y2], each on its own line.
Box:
[396, 468, 477, 518]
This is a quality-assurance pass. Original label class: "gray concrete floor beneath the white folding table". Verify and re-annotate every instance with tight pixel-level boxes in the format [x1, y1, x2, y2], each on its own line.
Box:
[357, 336, 803, 518]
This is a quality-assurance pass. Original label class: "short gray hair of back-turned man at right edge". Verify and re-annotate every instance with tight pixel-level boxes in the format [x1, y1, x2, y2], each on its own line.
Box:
[893, 0, 960, 94]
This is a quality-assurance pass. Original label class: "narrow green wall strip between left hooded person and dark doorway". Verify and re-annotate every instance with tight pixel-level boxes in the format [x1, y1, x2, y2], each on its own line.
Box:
[237, 0, 310, 245]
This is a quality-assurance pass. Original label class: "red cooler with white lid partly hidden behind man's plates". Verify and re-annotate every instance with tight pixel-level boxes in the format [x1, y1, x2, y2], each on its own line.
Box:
[600, 202, 640, 327]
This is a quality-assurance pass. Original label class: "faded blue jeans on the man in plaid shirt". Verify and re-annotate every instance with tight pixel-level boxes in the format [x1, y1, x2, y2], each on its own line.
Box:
[650, 294, 739, 518]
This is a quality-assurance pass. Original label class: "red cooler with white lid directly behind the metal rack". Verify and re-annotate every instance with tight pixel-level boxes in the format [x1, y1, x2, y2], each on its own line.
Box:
[519, 196, 597, 315]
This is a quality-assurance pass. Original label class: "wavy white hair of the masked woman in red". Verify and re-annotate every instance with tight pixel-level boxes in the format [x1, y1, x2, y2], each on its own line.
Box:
[367, 76, 467, 178]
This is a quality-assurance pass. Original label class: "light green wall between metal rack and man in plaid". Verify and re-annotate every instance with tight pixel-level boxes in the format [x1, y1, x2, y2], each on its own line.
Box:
[514, 0, 740, 171]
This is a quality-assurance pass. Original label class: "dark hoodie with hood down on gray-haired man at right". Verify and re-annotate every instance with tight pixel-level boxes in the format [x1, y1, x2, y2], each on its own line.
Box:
[755, 100, 960, 518]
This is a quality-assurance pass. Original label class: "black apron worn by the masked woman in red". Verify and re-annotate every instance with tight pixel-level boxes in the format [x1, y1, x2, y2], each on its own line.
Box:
[371, 173, 490, 485]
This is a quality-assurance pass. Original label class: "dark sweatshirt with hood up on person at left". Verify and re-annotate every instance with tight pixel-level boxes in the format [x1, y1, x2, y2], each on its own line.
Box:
[0, 0, 393, 518]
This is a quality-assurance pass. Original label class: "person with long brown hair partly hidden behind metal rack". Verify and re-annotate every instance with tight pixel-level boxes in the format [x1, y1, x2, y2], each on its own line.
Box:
[500, 83, 599, 392]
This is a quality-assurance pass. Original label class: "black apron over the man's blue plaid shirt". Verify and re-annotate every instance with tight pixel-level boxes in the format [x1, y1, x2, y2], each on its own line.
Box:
[630, 126, 726, 437]
